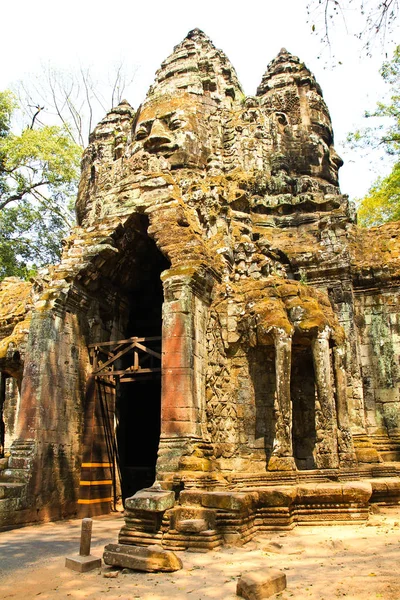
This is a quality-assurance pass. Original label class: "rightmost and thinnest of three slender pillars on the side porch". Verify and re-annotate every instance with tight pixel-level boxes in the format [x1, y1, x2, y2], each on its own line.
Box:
[333, 346, 357, 467]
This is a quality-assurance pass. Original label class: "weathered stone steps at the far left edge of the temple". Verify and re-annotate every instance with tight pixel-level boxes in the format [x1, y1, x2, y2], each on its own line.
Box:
[0, 440, 34, 530]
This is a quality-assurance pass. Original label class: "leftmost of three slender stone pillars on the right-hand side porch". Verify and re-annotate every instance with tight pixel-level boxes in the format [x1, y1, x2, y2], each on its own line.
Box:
[268, 334, 295, 471]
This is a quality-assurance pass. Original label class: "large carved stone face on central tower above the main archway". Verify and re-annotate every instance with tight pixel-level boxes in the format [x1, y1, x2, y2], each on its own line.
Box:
[133, 93, 212, 169]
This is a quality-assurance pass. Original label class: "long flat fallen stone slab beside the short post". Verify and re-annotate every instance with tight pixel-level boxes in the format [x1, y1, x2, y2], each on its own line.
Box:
[103, 544, 183, 573]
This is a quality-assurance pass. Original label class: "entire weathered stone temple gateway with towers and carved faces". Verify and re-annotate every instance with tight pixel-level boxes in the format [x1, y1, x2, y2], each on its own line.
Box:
[0, 29, 400, 549]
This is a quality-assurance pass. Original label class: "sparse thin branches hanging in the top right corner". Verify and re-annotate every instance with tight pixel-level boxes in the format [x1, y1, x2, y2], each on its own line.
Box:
[307, 0, 400, 55]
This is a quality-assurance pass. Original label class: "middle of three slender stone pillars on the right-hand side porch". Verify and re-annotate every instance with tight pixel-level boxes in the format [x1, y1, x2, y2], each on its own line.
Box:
[312, 329, 339, 469]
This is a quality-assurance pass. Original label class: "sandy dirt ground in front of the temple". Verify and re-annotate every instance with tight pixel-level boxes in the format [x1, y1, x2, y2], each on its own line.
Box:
[0, 507, 400, 600]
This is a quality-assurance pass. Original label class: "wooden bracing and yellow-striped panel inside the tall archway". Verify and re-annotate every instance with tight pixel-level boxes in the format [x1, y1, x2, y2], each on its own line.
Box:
[78, 336, 161, 516]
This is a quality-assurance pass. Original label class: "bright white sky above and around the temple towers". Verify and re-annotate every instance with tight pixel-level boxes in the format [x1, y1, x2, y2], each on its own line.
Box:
[0, 0, 400, 202]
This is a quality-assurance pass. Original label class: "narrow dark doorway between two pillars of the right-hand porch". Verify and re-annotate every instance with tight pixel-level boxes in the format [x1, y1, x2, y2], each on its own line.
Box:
[290, 344, 316, 470]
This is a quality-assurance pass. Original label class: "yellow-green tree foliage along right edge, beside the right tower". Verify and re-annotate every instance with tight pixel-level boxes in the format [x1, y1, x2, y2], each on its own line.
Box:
[349, 46, 400, 226]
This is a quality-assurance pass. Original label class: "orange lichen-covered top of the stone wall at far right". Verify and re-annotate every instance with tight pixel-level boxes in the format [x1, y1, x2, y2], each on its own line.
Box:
[349, 221, 400, 277]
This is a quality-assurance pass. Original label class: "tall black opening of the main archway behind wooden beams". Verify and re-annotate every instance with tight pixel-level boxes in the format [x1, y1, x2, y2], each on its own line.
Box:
[111, 217, 170, 500]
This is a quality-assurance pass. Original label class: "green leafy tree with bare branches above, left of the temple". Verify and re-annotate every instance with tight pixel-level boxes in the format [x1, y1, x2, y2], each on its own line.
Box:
[0, 63, 135, 280]
